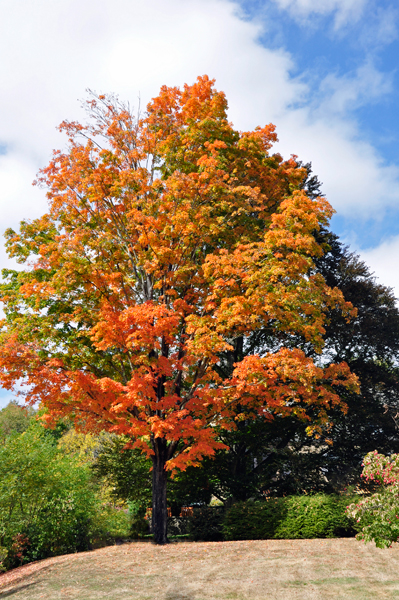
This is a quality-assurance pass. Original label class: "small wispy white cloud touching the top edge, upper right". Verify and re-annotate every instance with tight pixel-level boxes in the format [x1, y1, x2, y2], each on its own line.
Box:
[274, 0, 368, 28]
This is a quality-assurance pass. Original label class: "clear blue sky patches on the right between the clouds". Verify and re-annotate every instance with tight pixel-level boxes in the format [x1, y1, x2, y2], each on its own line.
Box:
[241, 0, 399, 248]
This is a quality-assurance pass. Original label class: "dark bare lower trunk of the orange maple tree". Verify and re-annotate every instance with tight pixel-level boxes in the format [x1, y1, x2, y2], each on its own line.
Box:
[152, 438, 168, 544]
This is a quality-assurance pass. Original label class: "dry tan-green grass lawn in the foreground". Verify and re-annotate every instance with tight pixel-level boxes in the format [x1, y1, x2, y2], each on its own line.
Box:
[0, 538, 399, 600]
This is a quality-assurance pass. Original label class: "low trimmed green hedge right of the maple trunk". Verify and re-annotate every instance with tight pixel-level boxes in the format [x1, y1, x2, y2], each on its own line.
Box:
[222, 494, 355, 540]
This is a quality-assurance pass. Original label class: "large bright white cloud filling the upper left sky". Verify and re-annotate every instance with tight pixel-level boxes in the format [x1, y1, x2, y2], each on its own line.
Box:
[0, 0, 304, 243]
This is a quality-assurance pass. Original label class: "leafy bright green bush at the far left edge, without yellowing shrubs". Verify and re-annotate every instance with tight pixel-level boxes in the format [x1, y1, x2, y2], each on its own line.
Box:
[0, 425, 97, 568]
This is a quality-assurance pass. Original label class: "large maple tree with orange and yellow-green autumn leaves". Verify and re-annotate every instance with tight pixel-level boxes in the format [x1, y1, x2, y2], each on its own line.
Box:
[0, 76, 357, 543]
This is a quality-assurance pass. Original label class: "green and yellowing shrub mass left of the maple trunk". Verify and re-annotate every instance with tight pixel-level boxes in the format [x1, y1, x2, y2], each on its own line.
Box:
[0, 403, 138, 570]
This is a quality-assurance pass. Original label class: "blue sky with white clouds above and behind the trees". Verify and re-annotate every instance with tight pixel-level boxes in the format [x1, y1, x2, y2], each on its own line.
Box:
[0, 0, 399, 402]
